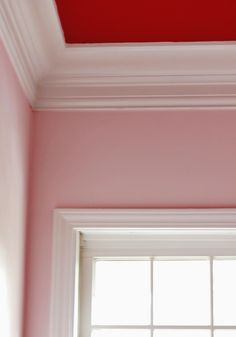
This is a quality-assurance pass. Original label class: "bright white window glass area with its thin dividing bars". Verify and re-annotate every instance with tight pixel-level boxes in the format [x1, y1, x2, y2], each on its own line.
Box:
[81, 256, 236, 337]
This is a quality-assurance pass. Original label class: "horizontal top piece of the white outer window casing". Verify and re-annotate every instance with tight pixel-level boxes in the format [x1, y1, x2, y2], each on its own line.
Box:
[54, 208, 236, 229]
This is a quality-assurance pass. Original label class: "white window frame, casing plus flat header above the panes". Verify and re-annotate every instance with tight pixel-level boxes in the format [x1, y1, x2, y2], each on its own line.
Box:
[50, 209, 236, 337]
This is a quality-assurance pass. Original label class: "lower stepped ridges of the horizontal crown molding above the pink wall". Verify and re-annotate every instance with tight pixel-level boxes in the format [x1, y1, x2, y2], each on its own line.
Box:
[34, 77, 236, 111]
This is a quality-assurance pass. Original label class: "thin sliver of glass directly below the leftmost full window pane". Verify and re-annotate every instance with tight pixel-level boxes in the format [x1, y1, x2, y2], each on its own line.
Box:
[92, 329, 150, 337]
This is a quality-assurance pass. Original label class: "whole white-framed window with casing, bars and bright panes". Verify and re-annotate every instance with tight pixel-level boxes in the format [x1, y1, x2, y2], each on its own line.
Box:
[50, 210, 236, 337]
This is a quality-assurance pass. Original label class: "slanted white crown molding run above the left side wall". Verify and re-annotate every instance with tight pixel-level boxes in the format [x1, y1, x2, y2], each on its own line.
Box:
[0, 0, 64, 105]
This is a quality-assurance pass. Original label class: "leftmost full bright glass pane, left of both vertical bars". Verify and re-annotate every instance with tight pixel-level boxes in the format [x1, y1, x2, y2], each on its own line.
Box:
[92, 261, 150, 325]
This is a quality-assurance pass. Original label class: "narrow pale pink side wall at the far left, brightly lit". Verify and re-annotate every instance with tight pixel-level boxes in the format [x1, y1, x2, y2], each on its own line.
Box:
[0, 41, 31, 337]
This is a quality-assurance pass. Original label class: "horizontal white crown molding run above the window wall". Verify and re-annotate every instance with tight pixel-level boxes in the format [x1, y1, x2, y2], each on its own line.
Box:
[35, 43, 236, 110]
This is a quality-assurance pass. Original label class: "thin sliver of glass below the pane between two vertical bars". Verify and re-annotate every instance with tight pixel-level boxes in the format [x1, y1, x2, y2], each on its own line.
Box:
[154, 329, 211, 337]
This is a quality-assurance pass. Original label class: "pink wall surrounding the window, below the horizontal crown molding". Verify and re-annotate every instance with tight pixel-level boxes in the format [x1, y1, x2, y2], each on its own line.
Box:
[25, 110, 236, 337]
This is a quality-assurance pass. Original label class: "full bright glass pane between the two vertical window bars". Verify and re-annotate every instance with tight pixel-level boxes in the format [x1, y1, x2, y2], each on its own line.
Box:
[153, 260, 210, 324]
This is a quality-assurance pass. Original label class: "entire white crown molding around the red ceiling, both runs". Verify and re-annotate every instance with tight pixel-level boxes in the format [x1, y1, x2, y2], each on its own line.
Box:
[0, 0, 236, 111]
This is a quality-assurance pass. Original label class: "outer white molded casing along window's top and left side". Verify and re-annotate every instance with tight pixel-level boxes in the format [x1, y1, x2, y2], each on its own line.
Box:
[50, 209, 236, 337]
